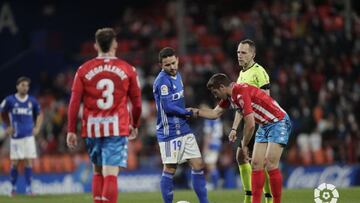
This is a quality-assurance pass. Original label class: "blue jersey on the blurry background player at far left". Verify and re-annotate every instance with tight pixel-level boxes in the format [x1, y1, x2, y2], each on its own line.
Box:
[1, 94, 40, 139]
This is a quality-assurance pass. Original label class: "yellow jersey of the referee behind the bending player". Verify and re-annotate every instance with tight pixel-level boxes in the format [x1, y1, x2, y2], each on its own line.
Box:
[236, 63, 270, 89]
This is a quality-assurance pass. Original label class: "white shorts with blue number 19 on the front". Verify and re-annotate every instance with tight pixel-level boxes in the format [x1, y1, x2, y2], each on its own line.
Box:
[159, 134, 201, 164]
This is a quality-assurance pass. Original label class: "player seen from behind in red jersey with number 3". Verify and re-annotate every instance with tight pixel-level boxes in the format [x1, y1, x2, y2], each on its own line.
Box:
[67, 28, 141, 203]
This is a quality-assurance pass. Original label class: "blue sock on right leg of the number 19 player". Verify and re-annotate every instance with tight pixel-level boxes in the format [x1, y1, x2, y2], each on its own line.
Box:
[191, 170, 209, 203]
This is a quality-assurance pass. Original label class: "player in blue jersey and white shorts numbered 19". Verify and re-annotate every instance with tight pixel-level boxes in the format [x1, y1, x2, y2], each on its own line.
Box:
[153, 47, 208, 203]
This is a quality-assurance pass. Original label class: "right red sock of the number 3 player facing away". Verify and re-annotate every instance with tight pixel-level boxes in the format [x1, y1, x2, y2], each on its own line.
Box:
[101, 175, 118, 203]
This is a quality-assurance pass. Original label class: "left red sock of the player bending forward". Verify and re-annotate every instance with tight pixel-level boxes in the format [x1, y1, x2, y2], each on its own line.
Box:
[251, 170, 266, 203]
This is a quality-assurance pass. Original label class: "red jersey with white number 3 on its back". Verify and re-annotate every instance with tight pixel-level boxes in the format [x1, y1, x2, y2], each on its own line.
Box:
[68, 57, 141, 137]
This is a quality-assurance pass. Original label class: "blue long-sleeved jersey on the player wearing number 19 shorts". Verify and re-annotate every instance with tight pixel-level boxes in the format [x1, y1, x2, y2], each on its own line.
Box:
[153, 71, 192, 142]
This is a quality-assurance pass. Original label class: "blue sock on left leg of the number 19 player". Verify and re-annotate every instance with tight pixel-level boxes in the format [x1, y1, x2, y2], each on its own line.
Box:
[160, 171, 174, 203]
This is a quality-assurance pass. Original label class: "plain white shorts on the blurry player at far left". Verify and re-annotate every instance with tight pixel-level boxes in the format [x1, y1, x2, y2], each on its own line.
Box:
[10, 136, 37, 160]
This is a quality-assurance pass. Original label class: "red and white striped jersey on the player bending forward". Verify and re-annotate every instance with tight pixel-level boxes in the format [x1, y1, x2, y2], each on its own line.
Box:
[219, 83, 286, 125]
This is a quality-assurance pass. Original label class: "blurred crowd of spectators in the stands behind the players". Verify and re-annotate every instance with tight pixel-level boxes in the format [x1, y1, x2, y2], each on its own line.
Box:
[0, 0, 360, 172]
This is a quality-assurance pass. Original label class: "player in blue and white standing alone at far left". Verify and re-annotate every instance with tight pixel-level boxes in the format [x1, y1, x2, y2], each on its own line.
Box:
[1, 76, 43, 196]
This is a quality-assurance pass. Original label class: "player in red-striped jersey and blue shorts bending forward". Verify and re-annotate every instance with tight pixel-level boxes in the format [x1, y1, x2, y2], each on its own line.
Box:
[192, 74, 291, 203]
